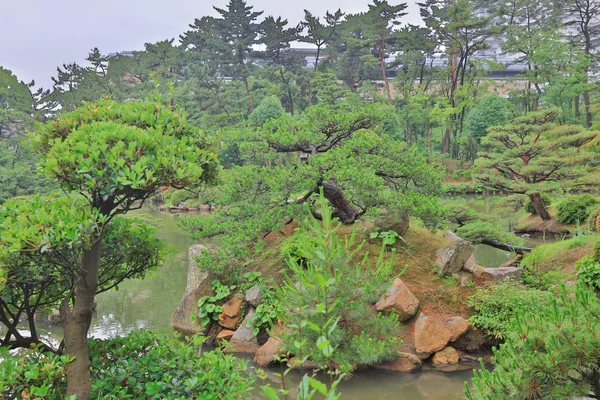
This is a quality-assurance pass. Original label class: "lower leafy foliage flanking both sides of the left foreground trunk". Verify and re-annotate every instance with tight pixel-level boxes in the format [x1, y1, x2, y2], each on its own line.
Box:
[0, 196, 166, 351]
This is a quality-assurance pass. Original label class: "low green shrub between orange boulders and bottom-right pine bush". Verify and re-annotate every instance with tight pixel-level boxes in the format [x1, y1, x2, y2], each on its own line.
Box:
[467, 282, 549, 339]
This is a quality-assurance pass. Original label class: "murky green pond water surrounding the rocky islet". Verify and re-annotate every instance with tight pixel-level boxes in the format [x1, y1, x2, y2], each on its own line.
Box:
[24, 197, 534, 400]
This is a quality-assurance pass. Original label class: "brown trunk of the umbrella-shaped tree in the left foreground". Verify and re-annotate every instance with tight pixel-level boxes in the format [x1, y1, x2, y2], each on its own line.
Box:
[61, 235, 102, 400]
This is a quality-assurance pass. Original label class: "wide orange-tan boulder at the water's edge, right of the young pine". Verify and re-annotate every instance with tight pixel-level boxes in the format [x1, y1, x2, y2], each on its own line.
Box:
[415, 313, 469, 359]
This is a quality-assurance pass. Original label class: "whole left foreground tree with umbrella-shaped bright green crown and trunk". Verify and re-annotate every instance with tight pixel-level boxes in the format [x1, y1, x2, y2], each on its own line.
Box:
[26, 93, 217, 398]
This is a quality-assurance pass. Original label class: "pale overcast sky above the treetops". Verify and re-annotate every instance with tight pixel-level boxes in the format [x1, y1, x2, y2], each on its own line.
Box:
[0, 0, 420, 87]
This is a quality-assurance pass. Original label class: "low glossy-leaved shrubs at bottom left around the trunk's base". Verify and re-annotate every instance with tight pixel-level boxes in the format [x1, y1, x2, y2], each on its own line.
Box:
[0, 330, 254, 399]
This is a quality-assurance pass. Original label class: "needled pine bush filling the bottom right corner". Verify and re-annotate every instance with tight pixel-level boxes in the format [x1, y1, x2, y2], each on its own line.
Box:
[466, 285, 600, 400]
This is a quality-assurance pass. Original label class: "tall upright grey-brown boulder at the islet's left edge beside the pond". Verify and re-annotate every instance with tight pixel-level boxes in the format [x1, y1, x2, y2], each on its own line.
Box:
[171, 244, 217, 335]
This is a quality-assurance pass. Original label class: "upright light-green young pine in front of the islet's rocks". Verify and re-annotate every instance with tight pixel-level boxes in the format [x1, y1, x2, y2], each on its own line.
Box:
[277, 200, 399, 370]
